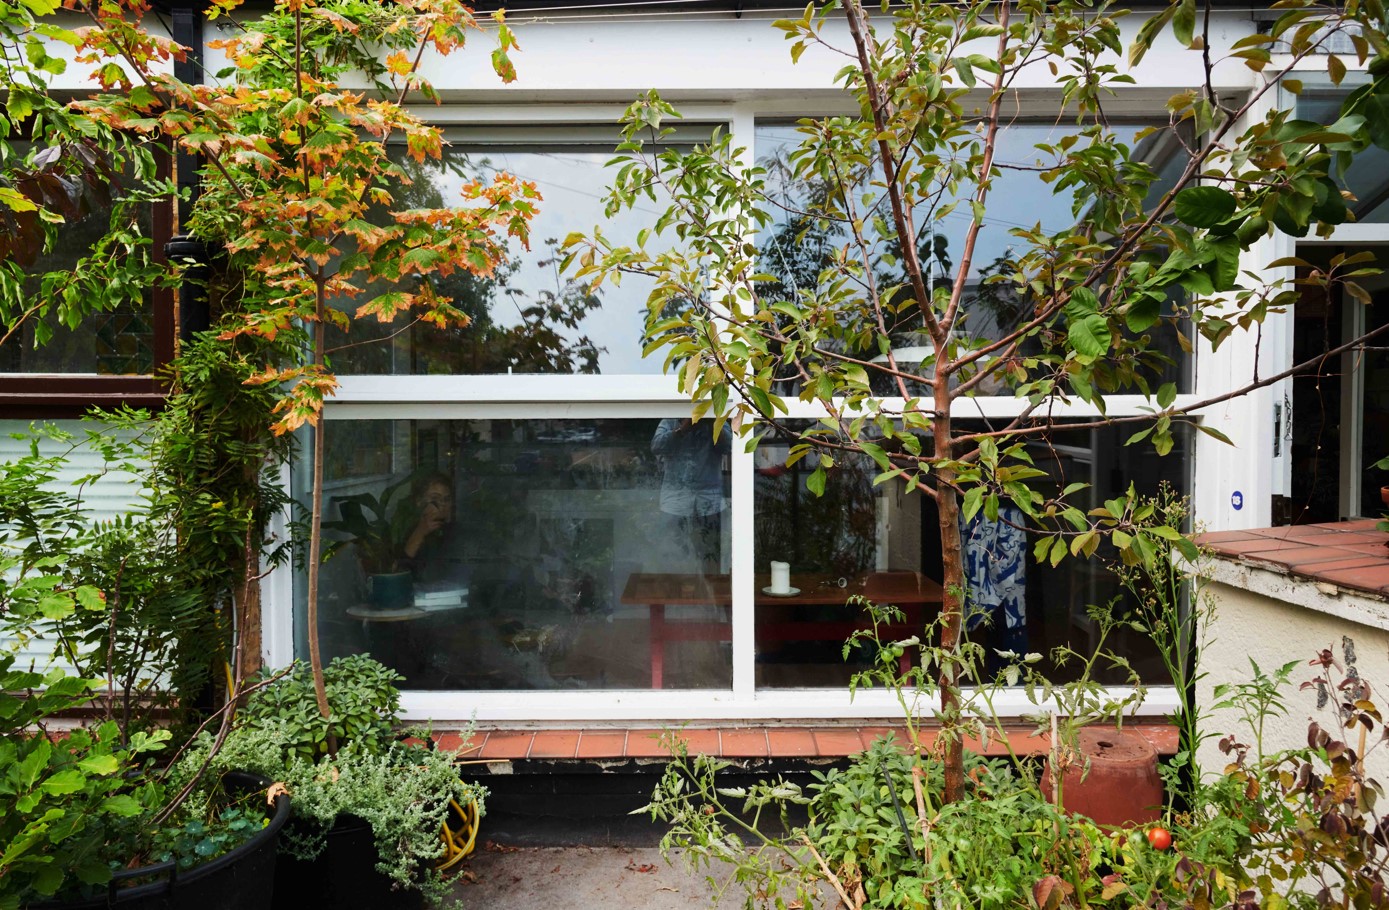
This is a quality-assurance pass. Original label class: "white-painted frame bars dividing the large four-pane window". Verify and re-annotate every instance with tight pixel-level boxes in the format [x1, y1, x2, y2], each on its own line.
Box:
[264, 101, 1199, 724]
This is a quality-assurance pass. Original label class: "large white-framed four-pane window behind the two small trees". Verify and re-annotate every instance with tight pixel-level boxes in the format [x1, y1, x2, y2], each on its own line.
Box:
[296, 117, 1190, 720]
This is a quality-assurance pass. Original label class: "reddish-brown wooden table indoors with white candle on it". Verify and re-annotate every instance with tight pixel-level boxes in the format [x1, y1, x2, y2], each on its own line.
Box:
[621, 572, 942, 689]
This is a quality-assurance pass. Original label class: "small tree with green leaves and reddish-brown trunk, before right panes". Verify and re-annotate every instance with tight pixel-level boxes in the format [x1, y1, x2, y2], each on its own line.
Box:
[567, 0, 1389, 799]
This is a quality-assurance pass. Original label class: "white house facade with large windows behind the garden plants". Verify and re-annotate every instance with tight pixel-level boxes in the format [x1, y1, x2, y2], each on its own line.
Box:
[0, 0, 1389, 755]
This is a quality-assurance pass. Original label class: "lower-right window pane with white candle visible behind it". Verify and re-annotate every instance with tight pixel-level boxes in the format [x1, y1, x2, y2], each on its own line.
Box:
[754, 428, 1188, 688]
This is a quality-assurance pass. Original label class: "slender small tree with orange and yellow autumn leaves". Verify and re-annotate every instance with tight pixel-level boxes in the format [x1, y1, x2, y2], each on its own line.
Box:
[68, 0, 538, 739]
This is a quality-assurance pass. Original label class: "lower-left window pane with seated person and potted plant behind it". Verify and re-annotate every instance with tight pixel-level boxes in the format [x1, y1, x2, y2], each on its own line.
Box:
[299, 420, 732, 689]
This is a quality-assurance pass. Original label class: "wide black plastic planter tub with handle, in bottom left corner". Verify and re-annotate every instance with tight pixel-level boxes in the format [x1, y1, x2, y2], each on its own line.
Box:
[28, 771, 290, 910]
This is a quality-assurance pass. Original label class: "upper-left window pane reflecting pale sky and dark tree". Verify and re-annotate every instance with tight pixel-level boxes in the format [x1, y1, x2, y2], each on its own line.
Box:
[328, 135, 694, 375]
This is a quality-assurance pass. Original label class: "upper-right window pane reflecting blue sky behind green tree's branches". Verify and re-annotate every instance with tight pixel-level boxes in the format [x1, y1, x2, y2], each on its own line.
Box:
[756, 124, 1190, 395]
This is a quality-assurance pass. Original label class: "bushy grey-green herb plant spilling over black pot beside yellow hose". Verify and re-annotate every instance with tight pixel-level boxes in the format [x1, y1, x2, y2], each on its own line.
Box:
[175, 654, 485, 906]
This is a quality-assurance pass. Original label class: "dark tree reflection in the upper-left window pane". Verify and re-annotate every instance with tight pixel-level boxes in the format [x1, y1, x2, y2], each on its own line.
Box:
[329, 153, 606, 374]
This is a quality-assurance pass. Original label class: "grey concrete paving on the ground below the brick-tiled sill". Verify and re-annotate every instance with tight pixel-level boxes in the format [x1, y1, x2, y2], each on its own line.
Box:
[454, 843, 743, 910]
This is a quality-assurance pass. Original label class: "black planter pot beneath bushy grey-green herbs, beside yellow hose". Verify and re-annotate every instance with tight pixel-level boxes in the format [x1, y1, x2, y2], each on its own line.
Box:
[274, 816, 424, 910]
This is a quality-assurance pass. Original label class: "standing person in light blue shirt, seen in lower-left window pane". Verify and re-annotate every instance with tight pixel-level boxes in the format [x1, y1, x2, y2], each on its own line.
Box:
[651, 417, 731, 575]
